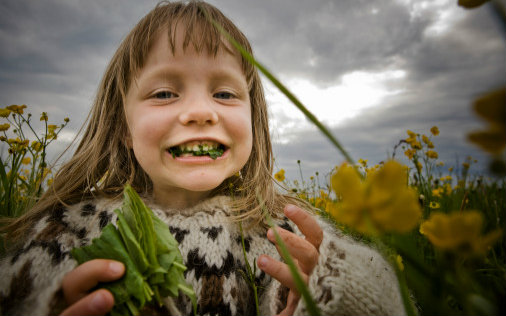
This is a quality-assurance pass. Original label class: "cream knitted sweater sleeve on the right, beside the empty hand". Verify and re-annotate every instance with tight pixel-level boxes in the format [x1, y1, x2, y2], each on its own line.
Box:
[262, 219, 405, 315]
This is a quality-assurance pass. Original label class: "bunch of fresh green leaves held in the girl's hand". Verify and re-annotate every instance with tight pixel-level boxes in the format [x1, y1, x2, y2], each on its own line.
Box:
[72, 185, 196, 315]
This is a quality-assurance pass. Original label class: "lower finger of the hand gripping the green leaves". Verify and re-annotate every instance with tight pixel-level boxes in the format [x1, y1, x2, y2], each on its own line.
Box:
[61, 289, 114, 316]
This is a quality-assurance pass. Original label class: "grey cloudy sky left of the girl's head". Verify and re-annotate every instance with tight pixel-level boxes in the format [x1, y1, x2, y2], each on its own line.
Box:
[0, 0, 155, 146]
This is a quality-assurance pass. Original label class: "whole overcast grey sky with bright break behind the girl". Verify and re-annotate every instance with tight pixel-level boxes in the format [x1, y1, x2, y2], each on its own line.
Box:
[0, 0, 506, 184]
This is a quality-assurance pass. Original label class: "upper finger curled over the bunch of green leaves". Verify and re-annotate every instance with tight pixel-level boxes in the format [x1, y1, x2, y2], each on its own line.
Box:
[62, 259, 125, 304]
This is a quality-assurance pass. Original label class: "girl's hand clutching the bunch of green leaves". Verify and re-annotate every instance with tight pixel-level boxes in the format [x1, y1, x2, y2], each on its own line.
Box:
[61, 259, 125, 316]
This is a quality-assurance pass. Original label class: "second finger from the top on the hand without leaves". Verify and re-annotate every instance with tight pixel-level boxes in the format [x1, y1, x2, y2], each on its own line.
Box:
[267, 227, 319, 274]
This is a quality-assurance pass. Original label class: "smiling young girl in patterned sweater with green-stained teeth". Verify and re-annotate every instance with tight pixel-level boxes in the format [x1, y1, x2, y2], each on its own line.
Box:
[0, 2, 404, 315]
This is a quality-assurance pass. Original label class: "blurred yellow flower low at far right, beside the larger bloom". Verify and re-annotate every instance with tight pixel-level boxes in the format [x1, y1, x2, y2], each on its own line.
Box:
[420, 210, 502, 255]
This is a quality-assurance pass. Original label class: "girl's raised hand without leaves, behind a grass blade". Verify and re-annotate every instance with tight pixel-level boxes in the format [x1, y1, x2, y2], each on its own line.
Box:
[258, 205, 323, 315]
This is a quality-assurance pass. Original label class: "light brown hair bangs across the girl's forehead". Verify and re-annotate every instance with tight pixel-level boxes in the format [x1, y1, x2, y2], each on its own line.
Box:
[123, 1, 255, 92]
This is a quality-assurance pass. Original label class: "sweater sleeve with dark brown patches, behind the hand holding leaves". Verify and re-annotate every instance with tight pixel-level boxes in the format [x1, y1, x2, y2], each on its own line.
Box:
[0, 204, 110, 315]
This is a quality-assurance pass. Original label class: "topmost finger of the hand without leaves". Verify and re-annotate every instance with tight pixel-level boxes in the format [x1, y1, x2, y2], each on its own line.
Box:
[284, 204, 323, 250]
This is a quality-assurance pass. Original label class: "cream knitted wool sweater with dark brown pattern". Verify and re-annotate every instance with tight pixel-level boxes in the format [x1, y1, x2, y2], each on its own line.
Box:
[0, 196, 405, 315]
